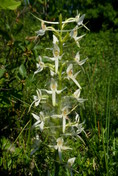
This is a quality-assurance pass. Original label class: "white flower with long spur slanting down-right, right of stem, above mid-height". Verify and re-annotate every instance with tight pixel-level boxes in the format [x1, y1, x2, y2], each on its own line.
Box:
[66, 64, 81, 89]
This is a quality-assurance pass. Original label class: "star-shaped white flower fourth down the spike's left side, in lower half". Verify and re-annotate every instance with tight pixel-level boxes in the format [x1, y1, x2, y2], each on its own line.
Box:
[32, 112, 44, 131]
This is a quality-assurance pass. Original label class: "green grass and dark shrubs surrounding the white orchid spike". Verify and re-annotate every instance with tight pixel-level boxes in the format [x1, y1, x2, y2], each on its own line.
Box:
[0, 0, 118, 176]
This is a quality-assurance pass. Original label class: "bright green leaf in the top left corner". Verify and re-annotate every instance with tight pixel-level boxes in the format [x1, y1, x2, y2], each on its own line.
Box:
[0, 0, 21, 10]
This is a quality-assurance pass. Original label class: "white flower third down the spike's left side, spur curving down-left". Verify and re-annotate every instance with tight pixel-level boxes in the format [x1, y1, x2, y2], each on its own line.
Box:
[29, 89, 46, 110]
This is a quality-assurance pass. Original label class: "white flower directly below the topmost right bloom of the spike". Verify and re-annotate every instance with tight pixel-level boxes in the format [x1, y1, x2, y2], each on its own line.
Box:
[70, 27, 85, 47]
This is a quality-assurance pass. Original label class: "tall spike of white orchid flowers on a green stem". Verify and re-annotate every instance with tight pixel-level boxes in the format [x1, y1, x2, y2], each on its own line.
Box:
[29, 14, 88, 175]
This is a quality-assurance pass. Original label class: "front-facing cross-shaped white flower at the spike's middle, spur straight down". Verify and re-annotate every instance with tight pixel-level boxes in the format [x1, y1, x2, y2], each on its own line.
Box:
[43, 78, 65, 106]
